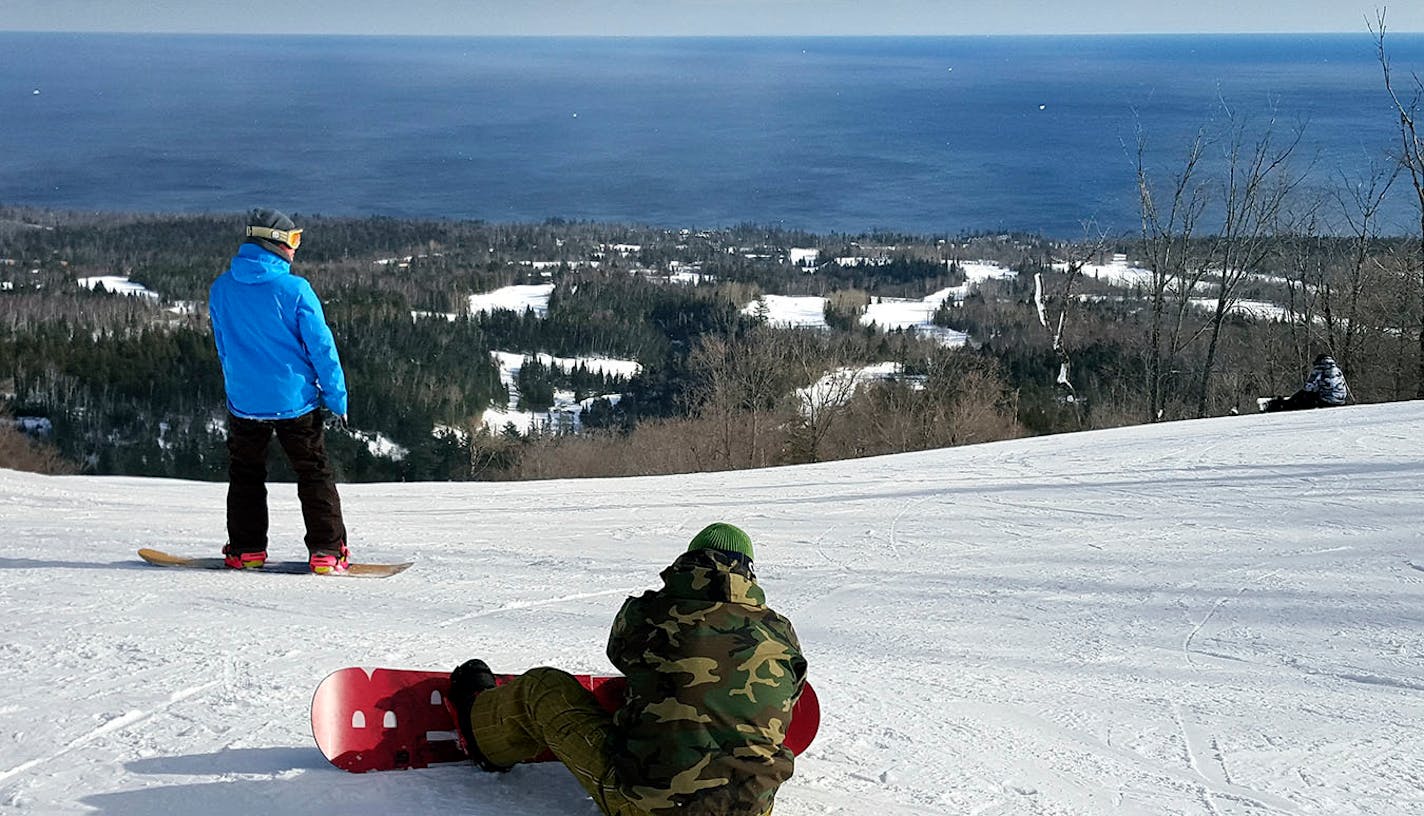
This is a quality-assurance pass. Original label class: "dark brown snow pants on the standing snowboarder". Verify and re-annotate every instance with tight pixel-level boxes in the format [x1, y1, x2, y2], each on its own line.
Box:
[228, 409, 346, 554]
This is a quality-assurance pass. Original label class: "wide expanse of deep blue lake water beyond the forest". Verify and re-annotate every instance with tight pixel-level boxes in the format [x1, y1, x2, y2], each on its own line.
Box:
[0, 31, 1424, 238]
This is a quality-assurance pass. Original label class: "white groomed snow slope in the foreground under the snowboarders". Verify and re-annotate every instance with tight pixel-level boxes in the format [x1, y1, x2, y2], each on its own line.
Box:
[0, 403, 1424, 816]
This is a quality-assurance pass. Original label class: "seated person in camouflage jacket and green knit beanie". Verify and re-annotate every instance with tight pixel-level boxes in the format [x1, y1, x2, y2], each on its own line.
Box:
[450, 523, 806, 816]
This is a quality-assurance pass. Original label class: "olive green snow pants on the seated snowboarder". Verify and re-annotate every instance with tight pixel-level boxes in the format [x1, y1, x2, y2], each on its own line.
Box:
[470, 666, 772, 816]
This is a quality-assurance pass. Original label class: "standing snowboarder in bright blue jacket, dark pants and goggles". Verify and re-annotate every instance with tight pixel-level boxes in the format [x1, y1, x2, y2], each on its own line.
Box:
[208, 209, 349, 572]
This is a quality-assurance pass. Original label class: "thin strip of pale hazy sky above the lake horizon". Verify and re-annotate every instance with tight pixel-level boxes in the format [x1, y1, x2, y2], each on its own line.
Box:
[0, 0, 1424, 36]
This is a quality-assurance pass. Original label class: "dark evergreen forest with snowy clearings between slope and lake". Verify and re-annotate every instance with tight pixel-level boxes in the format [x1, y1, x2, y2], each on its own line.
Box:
[0, 206, 1424, 481]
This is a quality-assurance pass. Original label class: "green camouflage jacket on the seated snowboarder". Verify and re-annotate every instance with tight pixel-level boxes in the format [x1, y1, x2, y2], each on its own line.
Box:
[608, 550, 806, 816]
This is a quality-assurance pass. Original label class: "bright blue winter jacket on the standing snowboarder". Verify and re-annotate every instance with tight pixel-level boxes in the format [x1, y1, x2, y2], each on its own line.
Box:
[208, 244, 346, 419]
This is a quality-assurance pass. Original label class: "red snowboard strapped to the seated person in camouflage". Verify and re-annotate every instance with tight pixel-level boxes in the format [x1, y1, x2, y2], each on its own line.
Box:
[312, 666, 820, 773]
